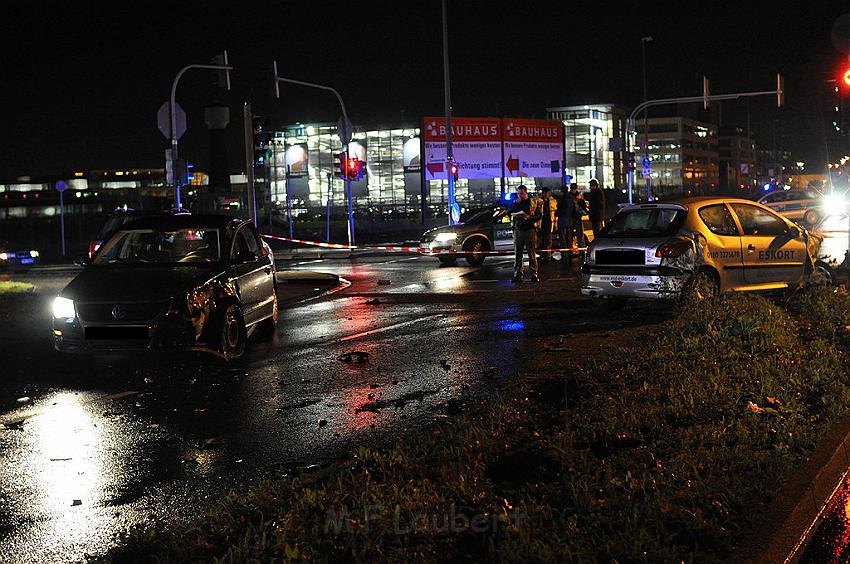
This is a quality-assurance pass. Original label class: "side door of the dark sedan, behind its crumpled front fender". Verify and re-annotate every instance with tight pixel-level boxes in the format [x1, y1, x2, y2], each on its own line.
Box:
[230, 224, 274, 325]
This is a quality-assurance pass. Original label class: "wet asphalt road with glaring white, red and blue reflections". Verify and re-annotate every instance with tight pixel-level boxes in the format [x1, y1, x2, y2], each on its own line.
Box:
[0, 255, 668, 562]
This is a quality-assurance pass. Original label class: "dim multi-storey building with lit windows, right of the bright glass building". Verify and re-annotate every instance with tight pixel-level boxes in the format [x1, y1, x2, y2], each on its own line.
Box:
[635, 117, 720, 197]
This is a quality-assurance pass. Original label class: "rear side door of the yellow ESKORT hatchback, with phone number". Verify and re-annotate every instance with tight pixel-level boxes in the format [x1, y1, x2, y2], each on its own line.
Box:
[697, 203, 745, 290]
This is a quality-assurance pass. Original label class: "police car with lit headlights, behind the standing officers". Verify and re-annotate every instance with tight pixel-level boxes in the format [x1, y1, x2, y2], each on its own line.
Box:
[420, 204, 593, 266]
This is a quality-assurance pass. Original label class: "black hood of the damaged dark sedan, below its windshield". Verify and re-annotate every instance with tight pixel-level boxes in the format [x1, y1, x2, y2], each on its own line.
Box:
[61, 265, 220, 301]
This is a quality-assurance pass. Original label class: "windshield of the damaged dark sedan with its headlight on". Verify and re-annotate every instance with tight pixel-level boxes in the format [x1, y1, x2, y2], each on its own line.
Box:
[93, 228, 221, 265]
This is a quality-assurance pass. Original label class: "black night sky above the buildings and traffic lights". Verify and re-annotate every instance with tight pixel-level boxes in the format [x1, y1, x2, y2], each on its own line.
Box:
[0, 0, 850, 180]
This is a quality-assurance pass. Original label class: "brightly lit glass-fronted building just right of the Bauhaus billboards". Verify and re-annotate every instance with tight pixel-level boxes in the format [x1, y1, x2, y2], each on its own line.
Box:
[546, 104, 628, 190]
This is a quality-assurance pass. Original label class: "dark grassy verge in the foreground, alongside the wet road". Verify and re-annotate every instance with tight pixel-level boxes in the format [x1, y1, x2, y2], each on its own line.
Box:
[101, 289, 850, 562]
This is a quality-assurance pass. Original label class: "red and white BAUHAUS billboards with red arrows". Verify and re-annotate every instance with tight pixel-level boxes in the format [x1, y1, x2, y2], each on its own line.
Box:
[422, 117, 564, 180]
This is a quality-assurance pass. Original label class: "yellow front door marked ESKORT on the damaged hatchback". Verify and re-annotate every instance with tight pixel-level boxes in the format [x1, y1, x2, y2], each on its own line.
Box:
[730, 203, 808, 285]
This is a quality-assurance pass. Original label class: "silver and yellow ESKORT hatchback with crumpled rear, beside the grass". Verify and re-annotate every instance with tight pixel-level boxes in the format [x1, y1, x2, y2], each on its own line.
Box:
[581, 197, 825, 299]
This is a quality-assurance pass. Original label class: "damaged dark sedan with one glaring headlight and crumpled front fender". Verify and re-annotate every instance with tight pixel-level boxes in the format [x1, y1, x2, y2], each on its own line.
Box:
[53, 215, 278, 360]
